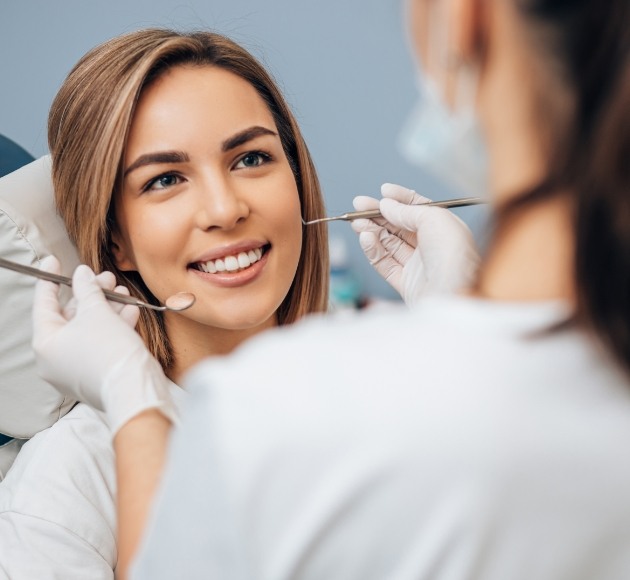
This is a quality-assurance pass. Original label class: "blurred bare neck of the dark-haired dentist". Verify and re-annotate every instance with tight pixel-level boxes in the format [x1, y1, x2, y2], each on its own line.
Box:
[477, 31, 575, 301]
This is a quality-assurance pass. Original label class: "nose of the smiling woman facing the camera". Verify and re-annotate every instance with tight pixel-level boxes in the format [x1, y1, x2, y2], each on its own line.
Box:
[196, 181, 249, 230]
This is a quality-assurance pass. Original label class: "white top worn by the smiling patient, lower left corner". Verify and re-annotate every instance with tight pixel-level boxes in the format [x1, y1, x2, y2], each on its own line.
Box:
[0, 384, 185, 580]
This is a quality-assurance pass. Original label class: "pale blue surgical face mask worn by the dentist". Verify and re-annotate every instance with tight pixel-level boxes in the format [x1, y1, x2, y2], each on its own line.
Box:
[399, 3, 489, 197]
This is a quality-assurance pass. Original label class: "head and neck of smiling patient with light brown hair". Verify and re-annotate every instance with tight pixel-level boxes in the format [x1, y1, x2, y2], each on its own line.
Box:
[49, 29, 328, 379]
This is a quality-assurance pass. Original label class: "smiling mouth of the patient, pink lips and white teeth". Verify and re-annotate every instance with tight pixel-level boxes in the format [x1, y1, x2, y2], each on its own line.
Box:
[190, 245, 271, 288]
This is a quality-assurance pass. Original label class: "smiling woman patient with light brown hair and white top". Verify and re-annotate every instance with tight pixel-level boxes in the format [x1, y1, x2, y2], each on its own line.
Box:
[0, 29, 328, 579]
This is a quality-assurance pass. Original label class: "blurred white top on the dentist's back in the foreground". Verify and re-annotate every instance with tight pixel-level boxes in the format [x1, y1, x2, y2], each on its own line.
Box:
[132, 297, 630, 580]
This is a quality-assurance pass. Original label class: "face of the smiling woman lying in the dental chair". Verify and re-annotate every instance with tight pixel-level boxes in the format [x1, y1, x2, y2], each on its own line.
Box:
[113, 66, 302, 330]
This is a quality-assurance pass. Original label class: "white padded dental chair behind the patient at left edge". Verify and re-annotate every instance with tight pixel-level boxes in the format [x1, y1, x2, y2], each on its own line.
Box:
[0, 152, 79, 480]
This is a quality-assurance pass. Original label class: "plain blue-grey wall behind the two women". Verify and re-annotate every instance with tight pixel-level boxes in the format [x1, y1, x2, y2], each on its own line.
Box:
[0, 0, 485, 298]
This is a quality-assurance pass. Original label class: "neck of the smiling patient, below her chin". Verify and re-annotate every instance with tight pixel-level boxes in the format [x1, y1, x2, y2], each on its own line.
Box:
[165, 314, 277, 385]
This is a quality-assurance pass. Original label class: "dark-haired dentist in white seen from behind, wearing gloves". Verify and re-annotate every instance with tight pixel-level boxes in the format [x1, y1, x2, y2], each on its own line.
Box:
[34, 0, 630, 580]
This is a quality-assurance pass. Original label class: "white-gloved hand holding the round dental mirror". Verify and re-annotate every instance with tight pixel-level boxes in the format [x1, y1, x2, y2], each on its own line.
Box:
[33, 257, 176, 434]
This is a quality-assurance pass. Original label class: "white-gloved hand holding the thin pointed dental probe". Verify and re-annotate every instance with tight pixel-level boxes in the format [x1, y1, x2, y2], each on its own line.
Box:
[352, 183, 480, 306]
